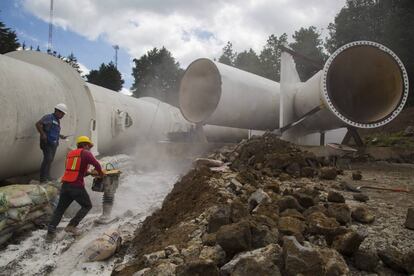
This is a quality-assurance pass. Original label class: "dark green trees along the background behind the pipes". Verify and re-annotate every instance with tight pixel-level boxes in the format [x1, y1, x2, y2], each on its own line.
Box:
[0, 0, 414, 105]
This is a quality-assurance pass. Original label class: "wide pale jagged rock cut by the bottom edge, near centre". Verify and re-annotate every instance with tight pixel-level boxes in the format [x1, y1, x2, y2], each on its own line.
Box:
[220, 244, 283, 276]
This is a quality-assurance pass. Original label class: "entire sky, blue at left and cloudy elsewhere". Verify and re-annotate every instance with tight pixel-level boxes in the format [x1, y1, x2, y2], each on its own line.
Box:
[0, 0, 345, 92]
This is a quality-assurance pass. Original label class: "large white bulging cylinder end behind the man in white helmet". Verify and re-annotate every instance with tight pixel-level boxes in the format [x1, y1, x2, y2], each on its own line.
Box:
[0, 51, 93, 179]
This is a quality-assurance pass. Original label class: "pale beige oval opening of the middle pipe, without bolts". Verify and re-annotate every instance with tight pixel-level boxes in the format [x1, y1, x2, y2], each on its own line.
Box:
[179, 59, 221, 123]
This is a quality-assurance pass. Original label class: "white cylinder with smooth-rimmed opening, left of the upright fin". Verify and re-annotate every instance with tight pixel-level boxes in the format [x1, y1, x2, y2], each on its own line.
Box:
[179, 58, 279, 129]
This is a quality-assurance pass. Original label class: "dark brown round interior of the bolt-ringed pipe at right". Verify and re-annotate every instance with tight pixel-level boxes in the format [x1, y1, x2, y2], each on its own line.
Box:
[325, 43, 407, 125]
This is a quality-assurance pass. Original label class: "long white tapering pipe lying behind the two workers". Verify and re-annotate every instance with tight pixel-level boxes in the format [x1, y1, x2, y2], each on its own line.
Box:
[0, 51, 249, 179]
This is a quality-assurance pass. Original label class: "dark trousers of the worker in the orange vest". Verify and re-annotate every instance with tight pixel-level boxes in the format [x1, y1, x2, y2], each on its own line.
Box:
[48, 183, 92, 232]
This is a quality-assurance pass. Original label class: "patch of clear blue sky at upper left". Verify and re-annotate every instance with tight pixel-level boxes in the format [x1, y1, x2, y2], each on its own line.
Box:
[0, 0, 133, 89]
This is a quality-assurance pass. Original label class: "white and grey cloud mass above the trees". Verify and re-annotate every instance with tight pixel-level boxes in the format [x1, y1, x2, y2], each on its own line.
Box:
[23, 0, 345, 66]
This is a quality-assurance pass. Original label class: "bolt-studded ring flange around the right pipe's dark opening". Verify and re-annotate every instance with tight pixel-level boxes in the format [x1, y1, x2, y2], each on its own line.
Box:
[321, 41, 409, 128]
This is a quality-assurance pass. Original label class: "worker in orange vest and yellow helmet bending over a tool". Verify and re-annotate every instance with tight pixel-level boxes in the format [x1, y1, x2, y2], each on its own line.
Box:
[48, 136, 104, 236]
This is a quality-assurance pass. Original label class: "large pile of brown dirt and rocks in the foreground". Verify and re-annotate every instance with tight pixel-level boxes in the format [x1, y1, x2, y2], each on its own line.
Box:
[114, 133, 414, 276]
